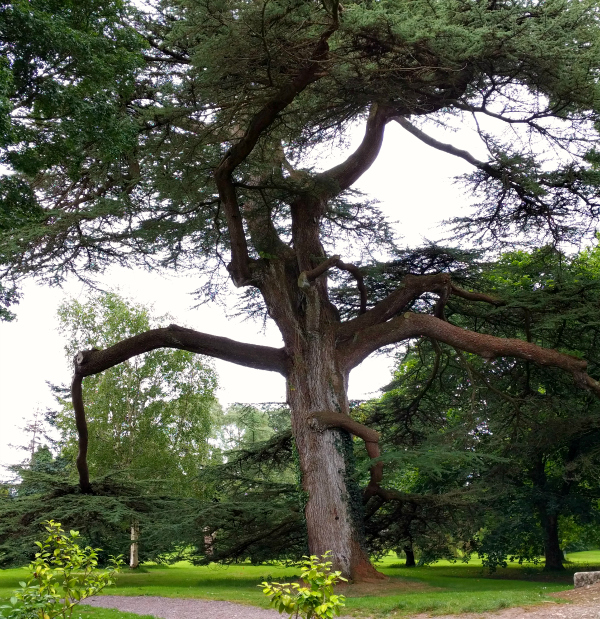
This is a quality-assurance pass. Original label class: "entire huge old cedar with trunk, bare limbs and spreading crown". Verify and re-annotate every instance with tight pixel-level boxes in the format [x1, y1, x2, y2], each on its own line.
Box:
[0, 0, 600, 577]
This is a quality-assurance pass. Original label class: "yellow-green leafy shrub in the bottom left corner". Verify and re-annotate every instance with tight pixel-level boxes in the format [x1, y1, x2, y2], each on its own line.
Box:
[0, 520, 123, 619]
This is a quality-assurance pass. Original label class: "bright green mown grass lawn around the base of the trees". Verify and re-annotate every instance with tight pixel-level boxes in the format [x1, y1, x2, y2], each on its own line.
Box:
[0, 551, 600, 619]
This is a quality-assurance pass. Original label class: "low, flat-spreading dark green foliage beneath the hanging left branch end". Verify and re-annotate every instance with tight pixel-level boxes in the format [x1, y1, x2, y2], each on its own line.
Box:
[0, 459, 209, 567]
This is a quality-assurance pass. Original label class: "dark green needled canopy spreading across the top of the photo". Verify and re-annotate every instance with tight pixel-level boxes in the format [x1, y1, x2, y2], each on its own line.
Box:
[0, 0, 600, 295]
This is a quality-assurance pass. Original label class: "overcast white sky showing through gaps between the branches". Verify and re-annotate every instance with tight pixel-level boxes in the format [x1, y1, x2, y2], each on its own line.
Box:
[0, 124, 479, 476]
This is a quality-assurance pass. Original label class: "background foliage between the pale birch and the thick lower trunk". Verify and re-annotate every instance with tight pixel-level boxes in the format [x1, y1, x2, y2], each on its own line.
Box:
[191, 403, 307, 564]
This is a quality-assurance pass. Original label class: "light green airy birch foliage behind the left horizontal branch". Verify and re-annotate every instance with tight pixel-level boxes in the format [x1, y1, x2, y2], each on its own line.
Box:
[53, 292, 218, 496]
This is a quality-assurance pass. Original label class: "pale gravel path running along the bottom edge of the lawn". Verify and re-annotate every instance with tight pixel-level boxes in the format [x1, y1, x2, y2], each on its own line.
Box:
[85, 583, 600, 619]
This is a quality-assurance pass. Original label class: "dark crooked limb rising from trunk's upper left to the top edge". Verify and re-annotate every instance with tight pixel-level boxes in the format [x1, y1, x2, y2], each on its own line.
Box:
[214, 20, 338, 286]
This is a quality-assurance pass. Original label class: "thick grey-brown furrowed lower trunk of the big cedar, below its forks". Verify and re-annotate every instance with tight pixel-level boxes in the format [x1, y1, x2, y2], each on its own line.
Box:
[287, 320, 385, 581]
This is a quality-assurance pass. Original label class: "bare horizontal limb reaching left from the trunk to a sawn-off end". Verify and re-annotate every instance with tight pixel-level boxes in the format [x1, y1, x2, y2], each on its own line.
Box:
[75, 325, 286, 377]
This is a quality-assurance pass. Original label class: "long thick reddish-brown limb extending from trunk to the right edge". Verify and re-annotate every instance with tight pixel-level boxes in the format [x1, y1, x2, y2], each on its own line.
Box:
[338, 312, 600, 396]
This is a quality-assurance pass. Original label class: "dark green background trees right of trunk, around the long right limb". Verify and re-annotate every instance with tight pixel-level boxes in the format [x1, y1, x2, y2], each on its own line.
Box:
[363, 247, 600, 567]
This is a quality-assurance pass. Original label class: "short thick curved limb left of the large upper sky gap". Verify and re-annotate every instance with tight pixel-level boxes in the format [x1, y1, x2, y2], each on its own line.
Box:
[317, 103, 391, 198]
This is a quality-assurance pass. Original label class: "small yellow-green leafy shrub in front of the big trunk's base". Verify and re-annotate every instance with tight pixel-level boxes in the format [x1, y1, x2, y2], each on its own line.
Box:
[258, 550, 346, 619]
